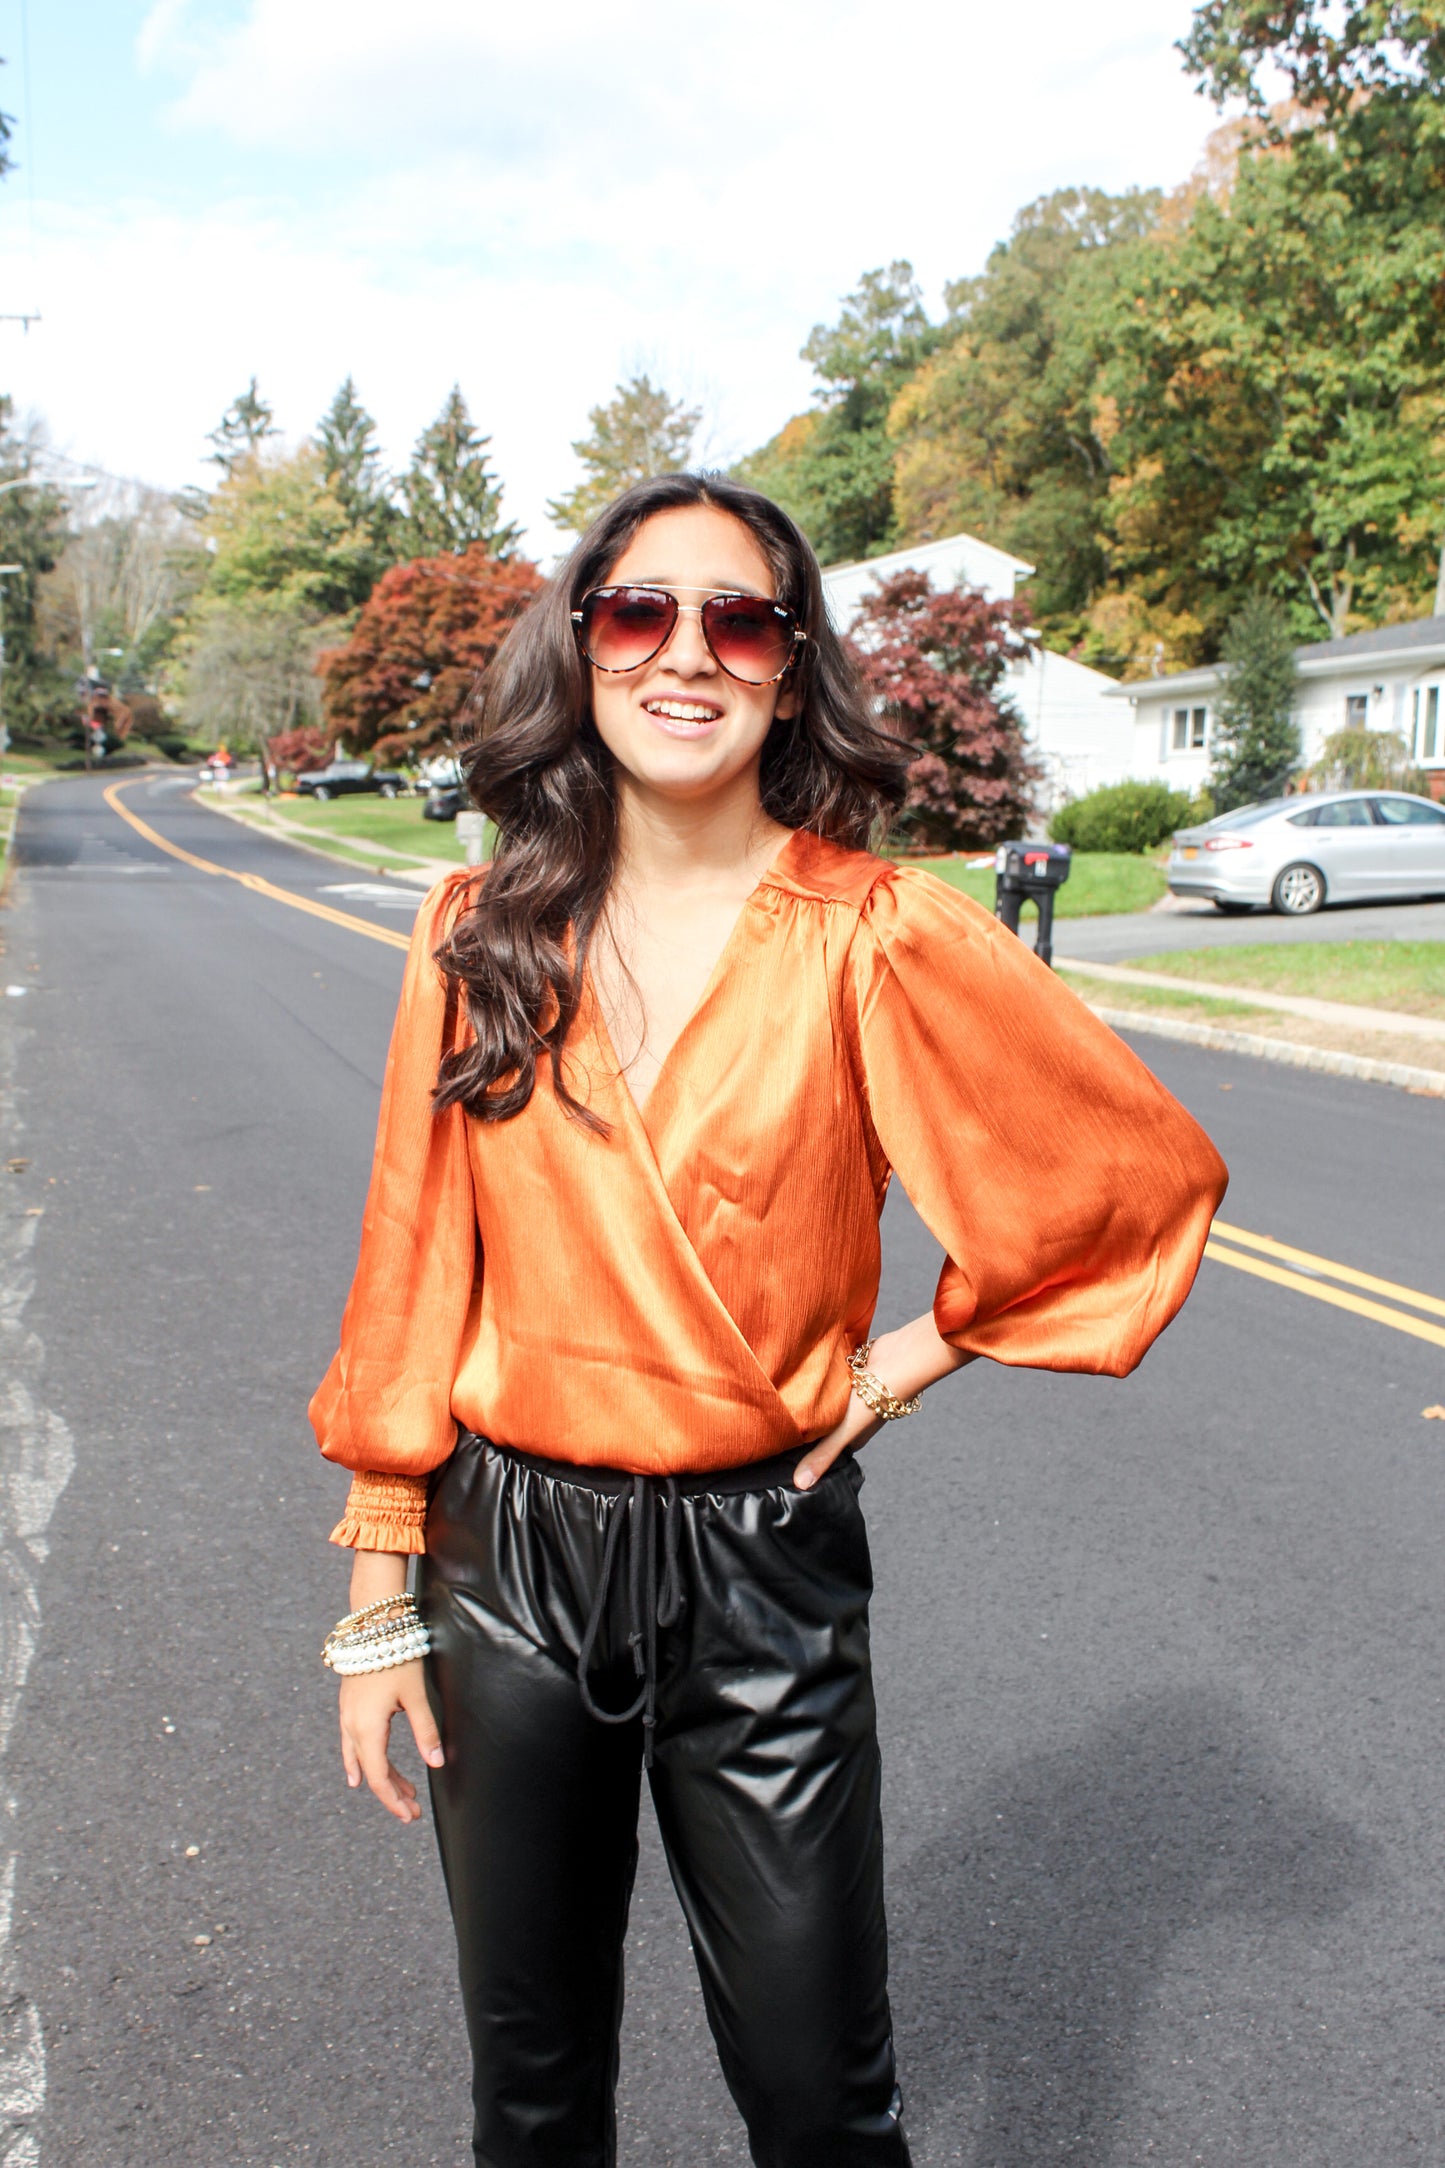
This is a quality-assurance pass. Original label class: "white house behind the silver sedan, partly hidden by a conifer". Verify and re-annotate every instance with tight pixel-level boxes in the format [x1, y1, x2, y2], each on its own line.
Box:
[1109, 618, 1445, 798]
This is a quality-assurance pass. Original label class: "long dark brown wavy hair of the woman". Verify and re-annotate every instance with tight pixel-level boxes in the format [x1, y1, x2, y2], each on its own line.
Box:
[435, 475, 910, 1127]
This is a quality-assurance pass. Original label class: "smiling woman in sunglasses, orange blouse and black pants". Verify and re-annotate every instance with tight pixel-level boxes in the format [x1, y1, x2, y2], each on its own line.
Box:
[312, 475, 1224, 2168]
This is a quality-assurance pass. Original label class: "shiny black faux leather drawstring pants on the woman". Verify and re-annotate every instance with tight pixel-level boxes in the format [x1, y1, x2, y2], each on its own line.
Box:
[422, 1435, 908, 2168]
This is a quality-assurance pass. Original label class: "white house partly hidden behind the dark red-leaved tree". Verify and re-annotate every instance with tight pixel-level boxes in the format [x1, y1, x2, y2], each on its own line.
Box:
[823, 535, 1135, 811]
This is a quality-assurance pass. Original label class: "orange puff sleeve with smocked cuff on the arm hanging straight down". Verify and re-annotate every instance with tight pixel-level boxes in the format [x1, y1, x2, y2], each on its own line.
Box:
[310, 869, 481, 1552]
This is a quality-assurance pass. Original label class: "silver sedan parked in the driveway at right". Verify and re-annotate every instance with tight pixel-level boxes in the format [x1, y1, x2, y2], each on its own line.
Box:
[1168, 791, 1445, 917]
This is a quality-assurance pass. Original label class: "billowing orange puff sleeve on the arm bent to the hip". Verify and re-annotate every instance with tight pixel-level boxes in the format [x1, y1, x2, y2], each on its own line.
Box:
[851, 867, 1228, 1377]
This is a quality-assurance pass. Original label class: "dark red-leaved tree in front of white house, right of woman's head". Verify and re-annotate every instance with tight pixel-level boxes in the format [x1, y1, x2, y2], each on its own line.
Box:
[851, 572, 1042, 850]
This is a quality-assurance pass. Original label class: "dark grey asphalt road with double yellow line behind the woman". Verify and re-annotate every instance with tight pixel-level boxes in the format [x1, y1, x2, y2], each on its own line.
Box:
[0, 778, 1445, 2168]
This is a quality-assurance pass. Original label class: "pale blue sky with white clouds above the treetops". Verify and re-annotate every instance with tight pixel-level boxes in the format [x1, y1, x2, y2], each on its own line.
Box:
[0, 0, 1218, 555]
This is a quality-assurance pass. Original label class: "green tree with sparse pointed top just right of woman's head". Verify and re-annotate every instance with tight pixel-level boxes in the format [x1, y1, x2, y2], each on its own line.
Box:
[734, 260, 940, 564]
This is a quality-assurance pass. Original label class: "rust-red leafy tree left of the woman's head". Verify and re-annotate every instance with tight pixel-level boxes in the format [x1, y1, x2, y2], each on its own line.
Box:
[316, 542, 542, 761]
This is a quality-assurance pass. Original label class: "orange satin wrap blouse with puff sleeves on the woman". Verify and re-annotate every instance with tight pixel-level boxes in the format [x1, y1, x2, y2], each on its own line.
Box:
[310, 833, 1226, 1550]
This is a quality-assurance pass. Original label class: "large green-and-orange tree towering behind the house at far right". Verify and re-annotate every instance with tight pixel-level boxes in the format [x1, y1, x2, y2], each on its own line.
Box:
[1101, 134, 1445, 668]
